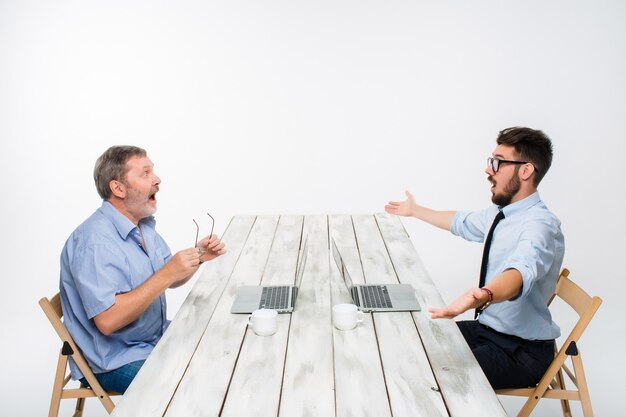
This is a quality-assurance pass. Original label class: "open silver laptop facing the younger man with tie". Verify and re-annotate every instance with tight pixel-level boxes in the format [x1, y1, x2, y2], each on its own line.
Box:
[332, 239, 421, 312]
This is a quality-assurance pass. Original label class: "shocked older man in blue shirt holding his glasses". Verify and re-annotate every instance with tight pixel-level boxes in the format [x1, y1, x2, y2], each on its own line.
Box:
[60, 146, 225, 393]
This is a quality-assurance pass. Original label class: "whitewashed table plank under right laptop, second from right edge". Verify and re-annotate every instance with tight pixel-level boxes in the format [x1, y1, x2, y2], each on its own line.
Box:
[352, 215, 448, 417]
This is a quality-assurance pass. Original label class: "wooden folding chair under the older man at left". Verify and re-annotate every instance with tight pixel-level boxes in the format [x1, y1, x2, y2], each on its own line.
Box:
[39, 293, 120, 417]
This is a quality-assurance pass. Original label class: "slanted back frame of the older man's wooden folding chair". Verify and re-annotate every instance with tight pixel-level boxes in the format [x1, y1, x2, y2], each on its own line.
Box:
[39, 293, 116, 413]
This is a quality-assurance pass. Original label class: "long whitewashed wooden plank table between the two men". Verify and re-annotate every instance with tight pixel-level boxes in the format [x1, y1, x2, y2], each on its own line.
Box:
[113, 214, 506, 417]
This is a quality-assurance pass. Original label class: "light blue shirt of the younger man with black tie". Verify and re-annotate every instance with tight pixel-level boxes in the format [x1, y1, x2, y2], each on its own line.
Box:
[450, 192, 565, 340]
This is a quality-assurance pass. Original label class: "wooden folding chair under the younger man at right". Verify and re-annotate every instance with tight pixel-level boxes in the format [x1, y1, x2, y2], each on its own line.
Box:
[496, 268, 602, 417]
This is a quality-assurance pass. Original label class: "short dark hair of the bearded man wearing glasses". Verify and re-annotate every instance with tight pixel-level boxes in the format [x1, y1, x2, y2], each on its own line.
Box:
[496, 127, 552, 187]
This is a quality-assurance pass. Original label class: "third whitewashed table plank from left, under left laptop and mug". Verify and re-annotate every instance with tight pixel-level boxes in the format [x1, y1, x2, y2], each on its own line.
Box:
[221, 216, 308, 417]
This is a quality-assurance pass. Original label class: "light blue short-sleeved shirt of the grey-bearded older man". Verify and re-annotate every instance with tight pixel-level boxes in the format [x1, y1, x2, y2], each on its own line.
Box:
[60, 201, 171, 379]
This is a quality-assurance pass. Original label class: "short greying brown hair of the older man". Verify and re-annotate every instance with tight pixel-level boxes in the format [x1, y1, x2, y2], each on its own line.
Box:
[93, 145, 147, 200]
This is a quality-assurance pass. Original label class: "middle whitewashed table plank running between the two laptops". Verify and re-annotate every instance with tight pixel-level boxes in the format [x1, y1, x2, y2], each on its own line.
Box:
[278, 216, 335, 417]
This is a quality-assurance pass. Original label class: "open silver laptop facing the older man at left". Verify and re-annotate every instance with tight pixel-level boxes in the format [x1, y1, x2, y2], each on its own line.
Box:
[230, 237, 308, 314]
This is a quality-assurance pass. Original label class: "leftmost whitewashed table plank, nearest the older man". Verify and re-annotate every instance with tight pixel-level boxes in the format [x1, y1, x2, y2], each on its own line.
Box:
[113, 217, 254, 417]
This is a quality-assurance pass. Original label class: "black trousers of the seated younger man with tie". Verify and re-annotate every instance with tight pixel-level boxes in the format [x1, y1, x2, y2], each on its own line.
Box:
[457, 320, 554, 389]
